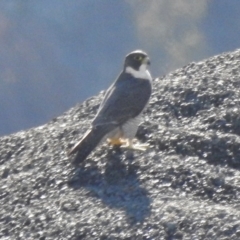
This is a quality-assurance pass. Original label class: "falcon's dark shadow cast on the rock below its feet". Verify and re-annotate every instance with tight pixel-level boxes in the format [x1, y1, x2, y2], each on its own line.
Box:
[69, 150, 150, 224]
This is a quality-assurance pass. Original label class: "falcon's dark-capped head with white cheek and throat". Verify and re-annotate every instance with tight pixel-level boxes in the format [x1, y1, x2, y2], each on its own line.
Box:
[124, 50, 150, 79]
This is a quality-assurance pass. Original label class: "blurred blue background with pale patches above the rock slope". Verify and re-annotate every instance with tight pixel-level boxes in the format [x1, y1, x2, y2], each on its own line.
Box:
[0, 0, 240, 135]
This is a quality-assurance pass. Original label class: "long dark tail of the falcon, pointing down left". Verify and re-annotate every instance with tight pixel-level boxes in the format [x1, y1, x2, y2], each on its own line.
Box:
[68, 126, 111, 164]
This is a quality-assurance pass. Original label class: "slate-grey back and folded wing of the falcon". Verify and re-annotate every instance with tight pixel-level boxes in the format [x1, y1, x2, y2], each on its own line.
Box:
[92, 72, 152, 126]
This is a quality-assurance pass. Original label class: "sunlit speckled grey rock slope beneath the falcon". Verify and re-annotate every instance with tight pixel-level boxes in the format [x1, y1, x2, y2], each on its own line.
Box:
[0, 50, 240, 240]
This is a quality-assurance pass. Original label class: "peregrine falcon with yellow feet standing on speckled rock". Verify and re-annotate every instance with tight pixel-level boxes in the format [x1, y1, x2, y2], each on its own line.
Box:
[69, 50, 152, 164]
